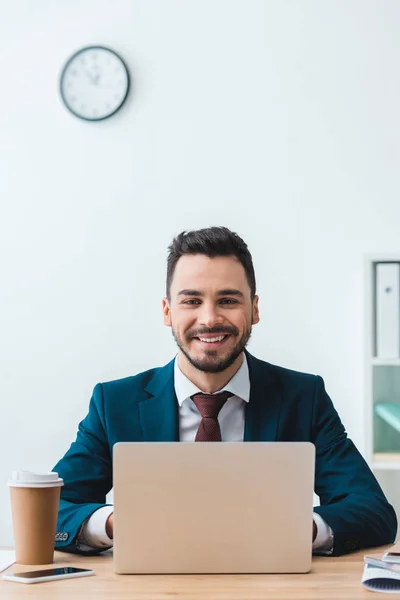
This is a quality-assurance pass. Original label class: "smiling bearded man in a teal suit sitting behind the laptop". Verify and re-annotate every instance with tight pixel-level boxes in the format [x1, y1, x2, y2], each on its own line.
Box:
[54, 227, 397, 555]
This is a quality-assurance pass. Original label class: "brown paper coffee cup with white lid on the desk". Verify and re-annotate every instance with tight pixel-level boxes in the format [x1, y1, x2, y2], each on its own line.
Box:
[7, 471, 64, 565]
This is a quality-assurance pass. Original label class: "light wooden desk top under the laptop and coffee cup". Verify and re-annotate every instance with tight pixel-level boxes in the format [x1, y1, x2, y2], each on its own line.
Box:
[0, 546, 389, 600]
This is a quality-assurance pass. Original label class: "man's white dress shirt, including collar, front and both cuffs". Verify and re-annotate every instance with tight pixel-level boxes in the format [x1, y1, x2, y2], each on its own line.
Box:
[78, 354, 333, 554]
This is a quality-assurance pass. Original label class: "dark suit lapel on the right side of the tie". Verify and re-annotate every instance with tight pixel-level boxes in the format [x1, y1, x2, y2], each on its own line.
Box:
[244, 351, 283, 442]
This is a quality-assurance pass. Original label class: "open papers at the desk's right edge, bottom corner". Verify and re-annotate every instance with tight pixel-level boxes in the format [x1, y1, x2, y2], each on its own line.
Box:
[361, 542, 400, 593]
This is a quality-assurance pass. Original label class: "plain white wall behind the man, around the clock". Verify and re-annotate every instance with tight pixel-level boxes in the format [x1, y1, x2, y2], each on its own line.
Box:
[0, 0, 400, 544]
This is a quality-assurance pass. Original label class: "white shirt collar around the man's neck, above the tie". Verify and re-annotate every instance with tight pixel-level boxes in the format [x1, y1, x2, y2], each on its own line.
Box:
[174, 353, 250, 406]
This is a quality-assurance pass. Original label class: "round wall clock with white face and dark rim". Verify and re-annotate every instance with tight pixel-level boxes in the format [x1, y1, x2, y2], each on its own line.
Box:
[60, 46, 129, 121]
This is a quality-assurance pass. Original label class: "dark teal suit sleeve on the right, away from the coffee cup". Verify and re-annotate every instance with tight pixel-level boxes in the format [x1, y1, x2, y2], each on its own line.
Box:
[312, 377, 397, 556]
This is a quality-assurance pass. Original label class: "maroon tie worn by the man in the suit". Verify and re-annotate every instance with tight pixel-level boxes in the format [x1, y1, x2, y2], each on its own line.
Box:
[191, 392, 233, 442]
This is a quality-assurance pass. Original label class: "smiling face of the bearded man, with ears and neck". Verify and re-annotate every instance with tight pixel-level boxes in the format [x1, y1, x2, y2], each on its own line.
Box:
[163, 251, 259, 393]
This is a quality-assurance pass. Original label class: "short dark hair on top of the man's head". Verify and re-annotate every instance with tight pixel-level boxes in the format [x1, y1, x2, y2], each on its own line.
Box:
[167, 227, 256, 300]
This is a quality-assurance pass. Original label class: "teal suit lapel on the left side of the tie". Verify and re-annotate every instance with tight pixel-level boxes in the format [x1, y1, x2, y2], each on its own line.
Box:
[139, 359, 179, 442]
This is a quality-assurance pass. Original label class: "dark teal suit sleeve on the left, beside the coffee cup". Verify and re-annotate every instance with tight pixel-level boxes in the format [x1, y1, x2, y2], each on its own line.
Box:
[53, 384, 112, 554]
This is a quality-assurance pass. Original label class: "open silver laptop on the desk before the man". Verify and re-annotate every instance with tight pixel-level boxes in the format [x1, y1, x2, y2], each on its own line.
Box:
[113, 442, 315, 574]
